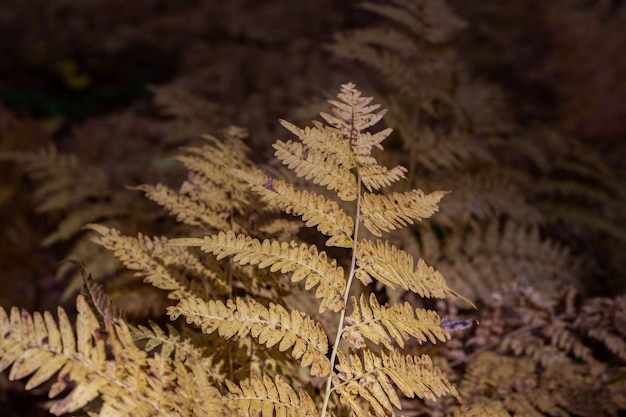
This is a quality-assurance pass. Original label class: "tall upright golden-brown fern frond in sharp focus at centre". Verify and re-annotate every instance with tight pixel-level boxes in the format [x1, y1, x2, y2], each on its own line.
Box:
[163, 84, 456, 415]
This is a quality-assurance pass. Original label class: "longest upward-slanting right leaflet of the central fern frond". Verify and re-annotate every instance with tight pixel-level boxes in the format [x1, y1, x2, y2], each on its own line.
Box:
[361, 190, 447, 236]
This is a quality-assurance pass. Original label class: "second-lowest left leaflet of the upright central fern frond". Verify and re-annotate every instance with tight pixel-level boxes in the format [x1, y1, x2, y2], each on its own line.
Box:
[167, 297, 330, 376]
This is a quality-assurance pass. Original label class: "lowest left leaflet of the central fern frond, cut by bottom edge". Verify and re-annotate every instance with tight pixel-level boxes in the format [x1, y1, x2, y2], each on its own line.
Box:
[225, 374, 319, 417]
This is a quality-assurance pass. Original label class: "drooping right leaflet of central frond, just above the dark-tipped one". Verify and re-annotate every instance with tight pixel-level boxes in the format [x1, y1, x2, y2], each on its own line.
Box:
[356, 240, 460, 298]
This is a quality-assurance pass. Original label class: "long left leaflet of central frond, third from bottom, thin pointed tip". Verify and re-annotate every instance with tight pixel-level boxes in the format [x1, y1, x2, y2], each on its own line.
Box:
[170, 231, 346, 312]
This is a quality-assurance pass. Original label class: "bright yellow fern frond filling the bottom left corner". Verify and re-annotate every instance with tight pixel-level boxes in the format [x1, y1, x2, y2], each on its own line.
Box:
[0, 296, 222, 417]
